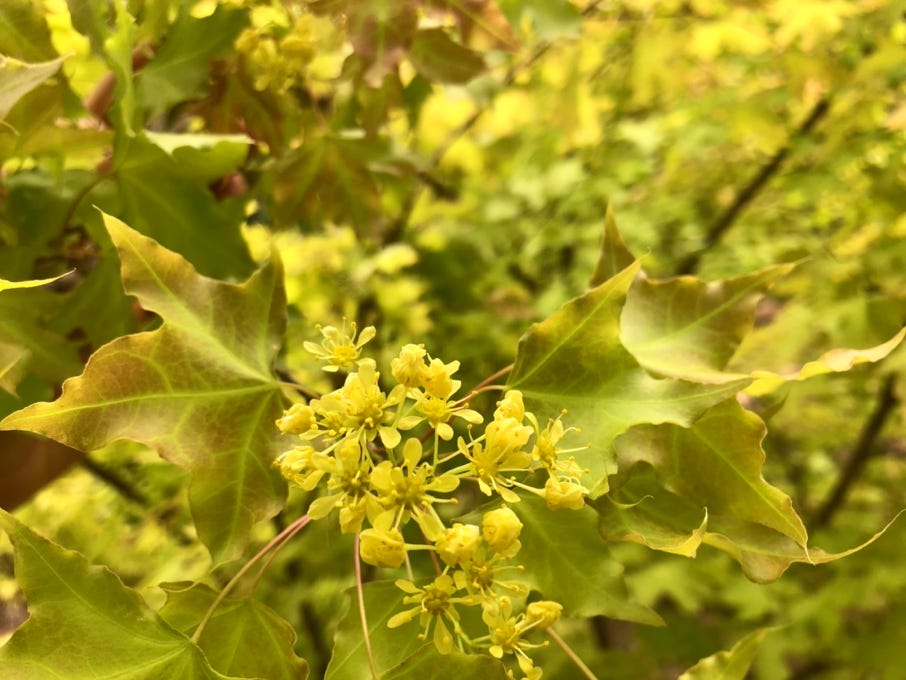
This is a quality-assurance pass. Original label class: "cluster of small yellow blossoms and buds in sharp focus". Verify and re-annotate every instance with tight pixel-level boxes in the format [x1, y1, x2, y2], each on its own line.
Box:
[275, 321, 588, 680]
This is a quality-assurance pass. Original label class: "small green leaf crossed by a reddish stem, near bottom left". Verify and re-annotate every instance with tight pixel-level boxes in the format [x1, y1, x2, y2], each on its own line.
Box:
[160, 583, 308, 680]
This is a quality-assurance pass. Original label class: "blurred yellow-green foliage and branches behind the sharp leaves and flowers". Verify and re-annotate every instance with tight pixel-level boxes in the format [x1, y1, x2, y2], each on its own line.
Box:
[0, 0, 906, 680]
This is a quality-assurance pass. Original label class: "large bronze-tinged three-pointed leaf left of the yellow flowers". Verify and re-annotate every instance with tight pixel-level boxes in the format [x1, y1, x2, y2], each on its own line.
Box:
[0, 215, 285, 560]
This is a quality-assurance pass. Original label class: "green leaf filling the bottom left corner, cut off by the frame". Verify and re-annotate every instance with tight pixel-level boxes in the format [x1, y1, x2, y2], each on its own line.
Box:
[0, 511, 240, 680]
